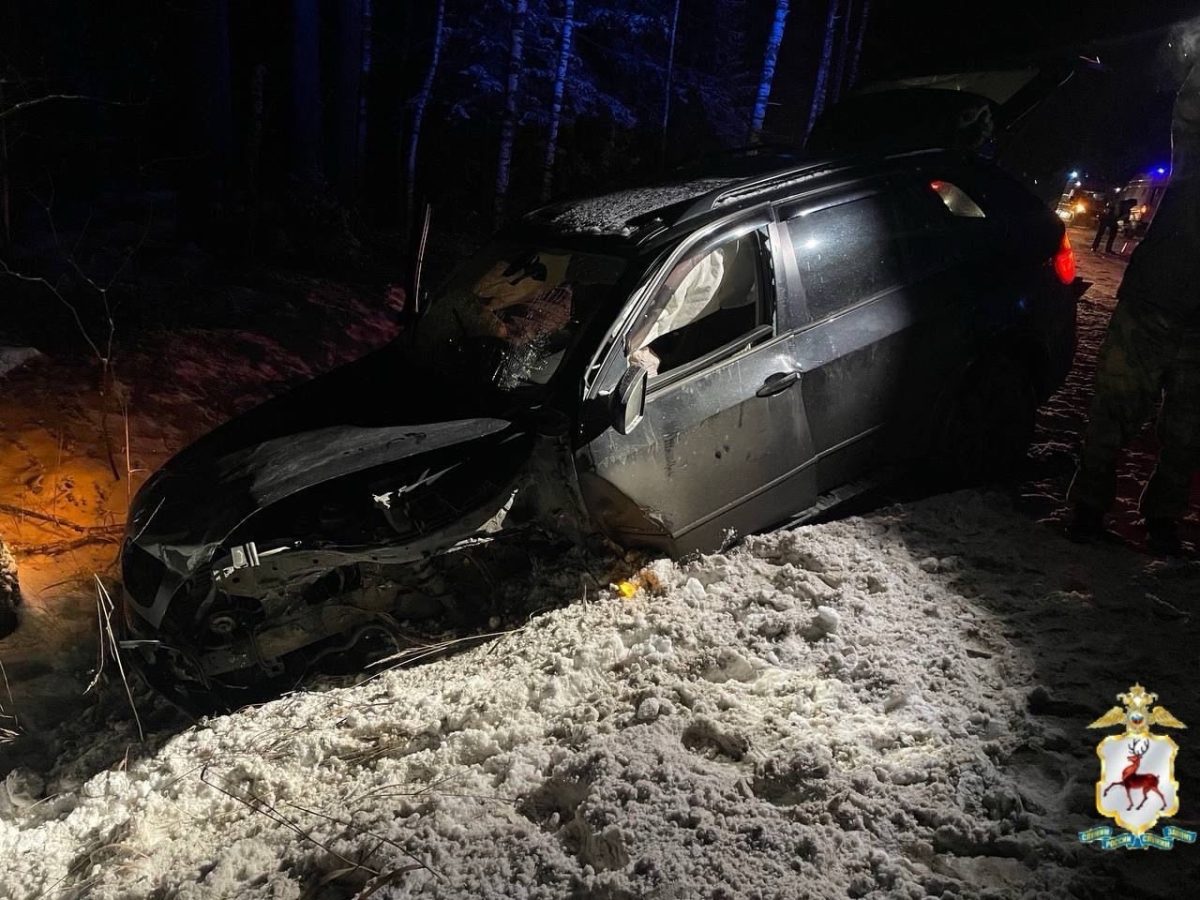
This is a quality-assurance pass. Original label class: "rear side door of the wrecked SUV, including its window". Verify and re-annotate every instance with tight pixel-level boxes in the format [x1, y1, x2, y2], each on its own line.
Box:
[780, 182, 944, 492]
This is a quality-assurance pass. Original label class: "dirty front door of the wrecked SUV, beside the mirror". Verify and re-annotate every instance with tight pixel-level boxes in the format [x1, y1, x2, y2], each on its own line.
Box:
[580, 218, 816, 554]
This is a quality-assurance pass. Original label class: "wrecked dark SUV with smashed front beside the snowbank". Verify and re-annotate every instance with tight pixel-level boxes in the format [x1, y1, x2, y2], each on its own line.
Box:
[122, 81, 1079, 706]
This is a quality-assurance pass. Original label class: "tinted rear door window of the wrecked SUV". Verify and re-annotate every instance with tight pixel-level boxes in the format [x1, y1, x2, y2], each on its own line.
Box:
[787, 196, 902, 319]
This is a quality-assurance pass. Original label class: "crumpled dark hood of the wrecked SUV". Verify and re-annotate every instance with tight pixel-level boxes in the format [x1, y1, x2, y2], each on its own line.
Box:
[125, 353, 530, 622]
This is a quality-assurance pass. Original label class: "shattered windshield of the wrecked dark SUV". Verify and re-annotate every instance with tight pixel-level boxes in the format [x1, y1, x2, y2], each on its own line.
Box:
[415, 242, 625, 391]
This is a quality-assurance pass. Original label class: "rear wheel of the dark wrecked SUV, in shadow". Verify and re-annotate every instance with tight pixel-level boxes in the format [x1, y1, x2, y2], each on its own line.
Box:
[934, 354, 1038, 487]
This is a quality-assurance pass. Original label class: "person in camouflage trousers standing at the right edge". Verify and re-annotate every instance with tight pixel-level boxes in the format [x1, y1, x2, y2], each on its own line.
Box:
[1067, 64, 1200, 554]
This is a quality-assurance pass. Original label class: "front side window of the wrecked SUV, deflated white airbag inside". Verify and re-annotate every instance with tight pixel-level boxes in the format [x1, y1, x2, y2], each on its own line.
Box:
[628, 232, 763, 377]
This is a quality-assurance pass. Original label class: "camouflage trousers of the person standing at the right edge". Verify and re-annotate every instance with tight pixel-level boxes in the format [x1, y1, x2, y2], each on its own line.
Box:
[1067, 297, 1200, 520]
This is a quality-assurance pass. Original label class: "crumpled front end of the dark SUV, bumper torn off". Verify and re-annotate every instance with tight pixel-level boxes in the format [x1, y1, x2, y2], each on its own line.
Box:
[122, 420, 583, 707]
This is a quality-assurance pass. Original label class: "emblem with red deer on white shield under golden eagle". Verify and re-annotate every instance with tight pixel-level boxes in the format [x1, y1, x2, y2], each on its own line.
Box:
[1079, 684, 1196, 850]
